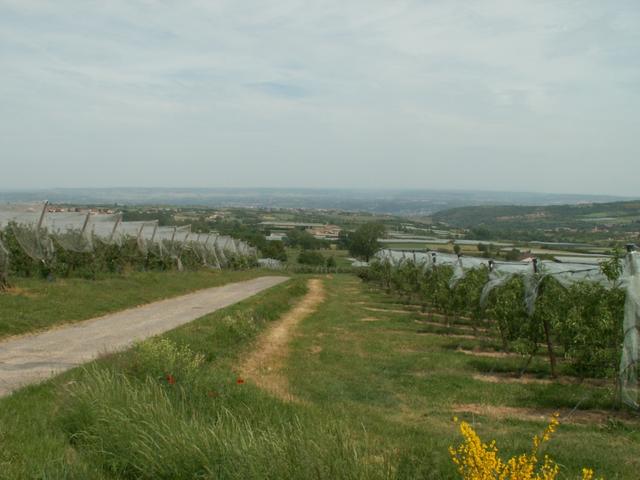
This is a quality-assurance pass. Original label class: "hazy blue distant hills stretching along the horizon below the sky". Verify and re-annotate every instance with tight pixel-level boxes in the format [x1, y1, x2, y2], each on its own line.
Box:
[0, 187, 625, 216]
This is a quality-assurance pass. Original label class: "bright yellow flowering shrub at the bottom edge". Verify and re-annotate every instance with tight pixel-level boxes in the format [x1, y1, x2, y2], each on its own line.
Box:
[449, 414, 594, 480]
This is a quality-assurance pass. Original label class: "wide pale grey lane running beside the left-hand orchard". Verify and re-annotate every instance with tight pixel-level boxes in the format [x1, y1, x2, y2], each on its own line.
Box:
[0, 277, 287, 396]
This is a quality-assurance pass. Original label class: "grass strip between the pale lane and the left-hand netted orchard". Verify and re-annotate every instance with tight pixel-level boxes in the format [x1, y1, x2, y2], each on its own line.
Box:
[0, 270, 264, 338]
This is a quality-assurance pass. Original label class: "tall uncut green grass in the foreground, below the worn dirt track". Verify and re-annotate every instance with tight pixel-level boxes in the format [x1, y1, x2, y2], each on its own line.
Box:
[60, 368, 389, 479]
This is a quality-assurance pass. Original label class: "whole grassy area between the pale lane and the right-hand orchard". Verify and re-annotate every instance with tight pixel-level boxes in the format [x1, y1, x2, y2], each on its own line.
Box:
[0, 275, 640, 479]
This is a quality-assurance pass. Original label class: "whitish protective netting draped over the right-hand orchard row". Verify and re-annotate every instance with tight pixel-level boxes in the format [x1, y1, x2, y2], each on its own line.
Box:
[373, 248, 640, 408]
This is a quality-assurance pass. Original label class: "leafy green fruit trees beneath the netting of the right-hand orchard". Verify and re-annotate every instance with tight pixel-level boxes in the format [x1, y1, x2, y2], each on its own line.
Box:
[360, 259, 624, 378]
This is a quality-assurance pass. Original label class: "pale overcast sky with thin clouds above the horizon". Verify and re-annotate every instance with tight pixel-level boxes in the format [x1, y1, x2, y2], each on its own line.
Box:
[0, 0, 640, 197]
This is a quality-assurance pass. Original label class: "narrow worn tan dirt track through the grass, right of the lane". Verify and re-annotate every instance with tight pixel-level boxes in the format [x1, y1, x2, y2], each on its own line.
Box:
[239, 278, 325, 402]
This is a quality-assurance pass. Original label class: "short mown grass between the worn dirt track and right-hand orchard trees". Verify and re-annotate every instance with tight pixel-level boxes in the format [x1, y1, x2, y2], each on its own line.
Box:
[288, 276, 640, 479]
